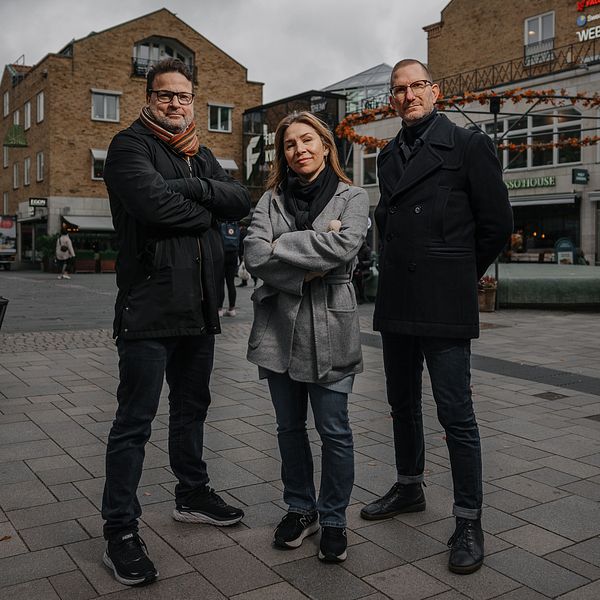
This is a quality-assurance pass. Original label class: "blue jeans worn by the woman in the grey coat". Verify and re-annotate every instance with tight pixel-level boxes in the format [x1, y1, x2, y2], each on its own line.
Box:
[268, 373, 354, 527]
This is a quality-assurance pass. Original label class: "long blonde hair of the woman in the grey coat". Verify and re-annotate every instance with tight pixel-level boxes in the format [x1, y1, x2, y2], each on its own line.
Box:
[266, 110, 352, 190]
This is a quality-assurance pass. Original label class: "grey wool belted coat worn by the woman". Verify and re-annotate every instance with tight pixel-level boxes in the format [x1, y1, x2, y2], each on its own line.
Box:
[244, 182, 369, 383]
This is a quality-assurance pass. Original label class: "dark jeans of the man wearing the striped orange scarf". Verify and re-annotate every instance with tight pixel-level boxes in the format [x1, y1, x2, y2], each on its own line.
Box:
[102, 335, 215, 539]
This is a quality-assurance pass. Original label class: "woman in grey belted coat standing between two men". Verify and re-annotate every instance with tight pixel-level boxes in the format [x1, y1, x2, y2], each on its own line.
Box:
[244, 112, 369, 562]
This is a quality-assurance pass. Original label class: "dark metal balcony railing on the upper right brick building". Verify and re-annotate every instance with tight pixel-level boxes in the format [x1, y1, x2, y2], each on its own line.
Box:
[437, 39, 600, 97]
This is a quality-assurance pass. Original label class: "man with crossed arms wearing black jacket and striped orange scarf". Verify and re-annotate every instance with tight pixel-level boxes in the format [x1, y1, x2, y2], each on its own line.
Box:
[102, 59, 250, 585]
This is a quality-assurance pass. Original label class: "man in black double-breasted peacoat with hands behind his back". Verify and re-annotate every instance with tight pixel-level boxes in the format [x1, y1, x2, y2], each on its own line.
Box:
[361, 59, 512, 573]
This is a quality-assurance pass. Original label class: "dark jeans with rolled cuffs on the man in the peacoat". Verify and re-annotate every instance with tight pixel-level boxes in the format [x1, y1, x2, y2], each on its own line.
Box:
[381, 333, 483, 519]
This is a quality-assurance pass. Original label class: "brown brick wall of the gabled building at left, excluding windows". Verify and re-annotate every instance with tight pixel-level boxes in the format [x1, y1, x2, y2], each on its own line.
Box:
[0, 9, 262, 213]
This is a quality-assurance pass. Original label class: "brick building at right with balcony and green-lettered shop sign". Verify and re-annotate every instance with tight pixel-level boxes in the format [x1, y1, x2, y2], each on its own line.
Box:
[354, 0, 600, 264]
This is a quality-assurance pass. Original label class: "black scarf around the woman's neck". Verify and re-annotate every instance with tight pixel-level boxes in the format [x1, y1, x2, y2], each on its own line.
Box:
[282, 164, 340, 231]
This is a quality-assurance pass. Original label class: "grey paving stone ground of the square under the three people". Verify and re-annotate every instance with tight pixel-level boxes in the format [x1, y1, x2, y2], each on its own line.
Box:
[0, 272, 600, 600]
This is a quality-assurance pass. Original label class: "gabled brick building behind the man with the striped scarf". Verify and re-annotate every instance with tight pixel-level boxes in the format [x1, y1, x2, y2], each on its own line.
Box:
[0, 9, 262, 260]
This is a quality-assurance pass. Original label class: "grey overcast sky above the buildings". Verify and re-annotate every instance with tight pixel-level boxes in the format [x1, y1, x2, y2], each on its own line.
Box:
[0, 0, 449, 102]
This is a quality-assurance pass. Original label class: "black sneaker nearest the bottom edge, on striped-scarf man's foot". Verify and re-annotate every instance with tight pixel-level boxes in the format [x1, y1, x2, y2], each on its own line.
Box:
[102, 532, 158, 585]
